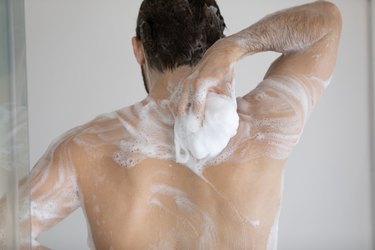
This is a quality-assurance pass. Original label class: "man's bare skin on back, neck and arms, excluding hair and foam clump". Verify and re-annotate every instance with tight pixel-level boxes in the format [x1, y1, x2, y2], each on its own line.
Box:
[4, 1, 341, 249]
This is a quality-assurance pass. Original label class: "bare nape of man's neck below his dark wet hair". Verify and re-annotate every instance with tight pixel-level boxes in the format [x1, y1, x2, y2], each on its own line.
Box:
[145, 66, 192, 100]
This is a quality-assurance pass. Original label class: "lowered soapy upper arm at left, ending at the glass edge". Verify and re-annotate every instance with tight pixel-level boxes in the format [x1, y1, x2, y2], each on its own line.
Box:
[30, 129, 80, 249]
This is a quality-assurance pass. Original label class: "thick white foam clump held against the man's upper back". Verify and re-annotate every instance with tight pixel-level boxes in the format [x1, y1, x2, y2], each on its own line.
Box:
[174, 93, 239, 168]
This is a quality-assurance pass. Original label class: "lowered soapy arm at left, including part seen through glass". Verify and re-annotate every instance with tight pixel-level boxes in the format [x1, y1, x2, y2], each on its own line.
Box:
[0, 134, 80, 250]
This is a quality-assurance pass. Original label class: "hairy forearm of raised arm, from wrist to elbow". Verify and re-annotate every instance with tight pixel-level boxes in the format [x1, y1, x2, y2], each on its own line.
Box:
[220, 1, 341, 61]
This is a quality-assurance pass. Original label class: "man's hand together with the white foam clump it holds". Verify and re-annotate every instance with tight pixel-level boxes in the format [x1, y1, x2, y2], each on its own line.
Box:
[172, 40, 239, 166]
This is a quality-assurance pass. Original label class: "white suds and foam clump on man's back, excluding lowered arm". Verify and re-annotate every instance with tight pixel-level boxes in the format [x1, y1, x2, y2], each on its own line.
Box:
[71, 73, 327, 249]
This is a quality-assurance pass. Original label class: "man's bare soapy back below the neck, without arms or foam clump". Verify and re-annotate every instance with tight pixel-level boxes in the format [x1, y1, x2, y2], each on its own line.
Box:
[57, 71, 323, 249]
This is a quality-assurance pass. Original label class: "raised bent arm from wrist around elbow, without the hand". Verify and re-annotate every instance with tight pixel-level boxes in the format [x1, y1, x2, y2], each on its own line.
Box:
[226, 1, 342, 79]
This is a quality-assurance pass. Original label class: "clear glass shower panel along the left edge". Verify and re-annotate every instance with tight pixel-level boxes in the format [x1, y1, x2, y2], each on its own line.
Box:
[0, 0, 31, 250]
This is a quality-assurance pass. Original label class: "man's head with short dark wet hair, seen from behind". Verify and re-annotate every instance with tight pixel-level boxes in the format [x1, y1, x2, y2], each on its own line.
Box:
[133, 0, 225, 92]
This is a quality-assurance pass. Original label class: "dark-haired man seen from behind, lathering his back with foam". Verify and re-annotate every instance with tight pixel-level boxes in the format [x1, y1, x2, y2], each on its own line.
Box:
[26, 0, 341, 249]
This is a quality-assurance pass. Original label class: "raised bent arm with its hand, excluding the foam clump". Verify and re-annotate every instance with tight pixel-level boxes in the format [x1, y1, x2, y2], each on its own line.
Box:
[179, 1, 341, 119]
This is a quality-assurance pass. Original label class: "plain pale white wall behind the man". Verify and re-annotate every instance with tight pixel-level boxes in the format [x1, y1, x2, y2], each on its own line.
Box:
[26, 0, 372, 250]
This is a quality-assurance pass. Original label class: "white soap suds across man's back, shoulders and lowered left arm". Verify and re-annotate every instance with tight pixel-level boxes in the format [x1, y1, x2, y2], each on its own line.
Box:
[31, 71, 328, 249]
